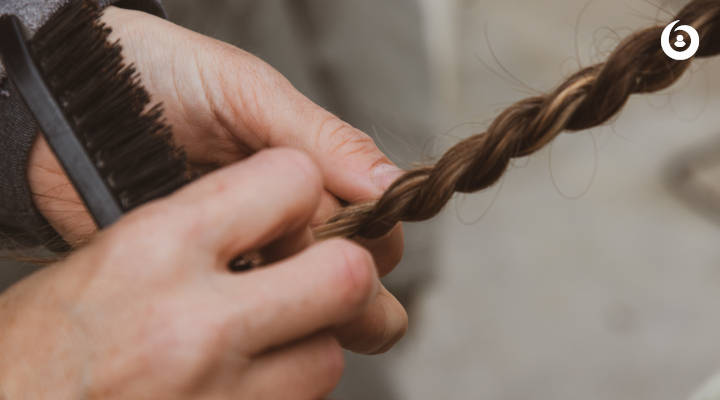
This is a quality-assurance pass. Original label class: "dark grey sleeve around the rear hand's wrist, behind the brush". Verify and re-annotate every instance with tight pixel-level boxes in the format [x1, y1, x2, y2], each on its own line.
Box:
[0, 0, 165, 248]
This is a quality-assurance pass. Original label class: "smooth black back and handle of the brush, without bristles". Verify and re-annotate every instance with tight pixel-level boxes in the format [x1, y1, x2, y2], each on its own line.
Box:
[0, 15, 123, 229]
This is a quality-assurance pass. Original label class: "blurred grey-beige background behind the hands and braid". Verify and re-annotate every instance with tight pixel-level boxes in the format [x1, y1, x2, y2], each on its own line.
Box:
[0, 0, 720, 400]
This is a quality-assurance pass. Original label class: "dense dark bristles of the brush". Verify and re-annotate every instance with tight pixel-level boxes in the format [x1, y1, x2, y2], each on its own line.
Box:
[30, 1, 189, 211]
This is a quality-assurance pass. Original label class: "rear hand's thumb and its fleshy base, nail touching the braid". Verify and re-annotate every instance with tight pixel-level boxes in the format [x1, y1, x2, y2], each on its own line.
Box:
[104, 8, 401, 201]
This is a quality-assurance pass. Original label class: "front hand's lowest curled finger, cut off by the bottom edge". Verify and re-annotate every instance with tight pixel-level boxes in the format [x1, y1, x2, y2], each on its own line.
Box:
[240, 333, 345, 400]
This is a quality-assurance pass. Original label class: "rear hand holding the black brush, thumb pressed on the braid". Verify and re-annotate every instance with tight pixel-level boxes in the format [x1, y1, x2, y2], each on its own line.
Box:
[29, 7, 407, 353]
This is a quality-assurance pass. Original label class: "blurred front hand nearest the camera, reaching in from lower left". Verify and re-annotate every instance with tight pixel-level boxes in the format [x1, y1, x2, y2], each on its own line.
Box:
[0, 149, 380, 400]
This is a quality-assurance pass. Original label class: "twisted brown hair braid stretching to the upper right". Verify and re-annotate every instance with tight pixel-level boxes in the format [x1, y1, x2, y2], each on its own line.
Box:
[316, 0, 720, 238]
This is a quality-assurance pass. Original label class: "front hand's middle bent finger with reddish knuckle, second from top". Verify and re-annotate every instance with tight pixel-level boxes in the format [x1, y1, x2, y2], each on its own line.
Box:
[225, 240, 379, 354]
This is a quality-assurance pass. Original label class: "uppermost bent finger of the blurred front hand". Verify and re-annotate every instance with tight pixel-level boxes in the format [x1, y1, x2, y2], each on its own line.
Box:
[164, 149, 322, 263]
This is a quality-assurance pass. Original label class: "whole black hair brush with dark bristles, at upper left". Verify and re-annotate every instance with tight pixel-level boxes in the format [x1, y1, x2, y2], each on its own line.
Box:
[0, 0, 190, 229]
